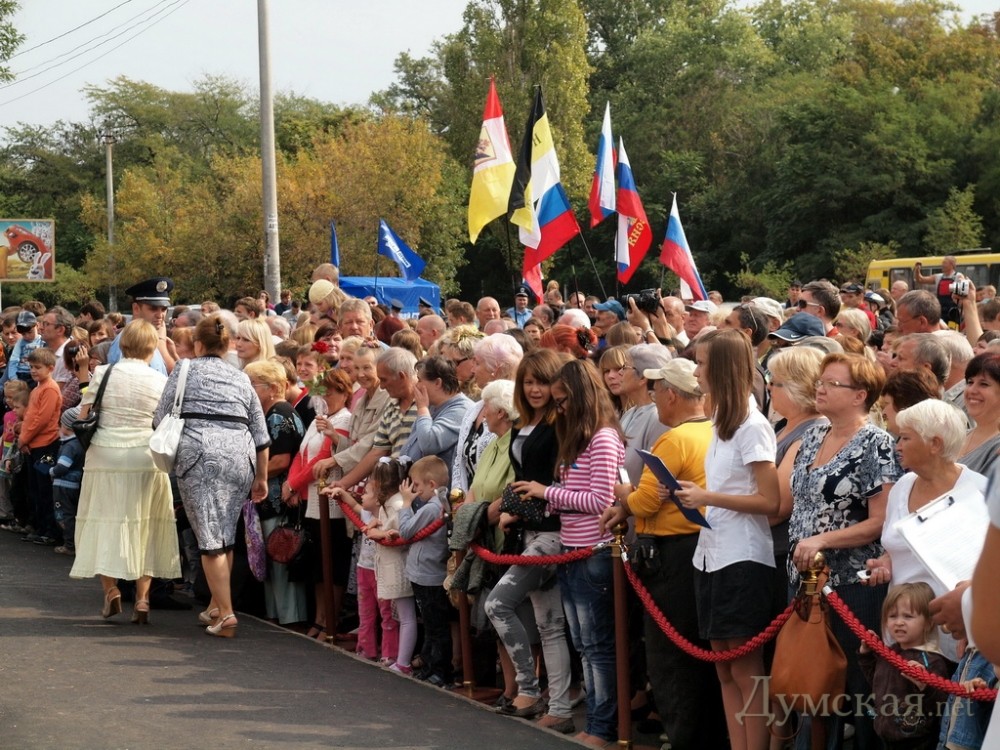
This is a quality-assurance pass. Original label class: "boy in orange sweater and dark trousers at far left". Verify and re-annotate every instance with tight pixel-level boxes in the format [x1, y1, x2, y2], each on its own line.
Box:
[20, 346, 62, 547]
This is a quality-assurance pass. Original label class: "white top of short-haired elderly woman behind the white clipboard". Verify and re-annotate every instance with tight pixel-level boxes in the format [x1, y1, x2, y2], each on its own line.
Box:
[882, 466, 986, 662]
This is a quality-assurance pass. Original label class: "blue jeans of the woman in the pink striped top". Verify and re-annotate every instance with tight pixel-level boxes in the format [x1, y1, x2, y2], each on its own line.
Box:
[558, 548, 618, 741]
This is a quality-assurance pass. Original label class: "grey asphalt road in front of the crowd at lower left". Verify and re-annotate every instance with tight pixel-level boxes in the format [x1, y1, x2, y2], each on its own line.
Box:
[0, 532, 582, 750]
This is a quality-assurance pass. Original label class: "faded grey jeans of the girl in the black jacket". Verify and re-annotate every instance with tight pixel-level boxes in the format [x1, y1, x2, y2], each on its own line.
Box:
[485, 531, 573, 719]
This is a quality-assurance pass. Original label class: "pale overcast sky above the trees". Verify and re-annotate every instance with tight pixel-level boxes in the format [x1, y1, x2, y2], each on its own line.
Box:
[0, 0, 1000, 125]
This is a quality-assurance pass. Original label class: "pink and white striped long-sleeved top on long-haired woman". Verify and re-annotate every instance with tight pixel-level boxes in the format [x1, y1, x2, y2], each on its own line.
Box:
[545, 427, 625, 547]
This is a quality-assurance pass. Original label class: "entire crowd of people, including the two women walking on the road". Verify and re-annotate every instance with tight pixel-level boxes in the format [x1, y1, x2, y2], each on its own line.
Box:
[0, 264, 1000, 750]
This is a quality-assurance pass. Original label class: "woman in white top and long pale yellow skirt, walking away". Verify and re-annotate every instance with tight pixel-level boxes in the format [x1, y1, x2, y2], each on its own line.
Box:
[70, 320, 180, 624]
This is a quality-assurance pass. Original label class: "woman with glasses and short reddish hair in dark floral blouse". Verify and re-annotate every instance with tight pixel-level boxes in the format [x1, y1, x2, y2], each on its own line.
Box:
[788, 354, 902, 748]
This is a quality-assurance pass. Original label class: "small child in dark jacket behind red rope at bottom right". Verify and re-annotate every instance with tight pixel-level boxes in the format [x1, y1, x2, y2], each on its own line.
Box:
[858, 583, 952, 750]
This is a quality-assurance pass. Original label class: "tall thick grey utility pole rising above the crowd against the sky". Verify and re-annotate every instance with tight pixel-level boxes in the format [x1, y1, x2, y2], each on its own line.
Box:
[257, 0, 281, 300]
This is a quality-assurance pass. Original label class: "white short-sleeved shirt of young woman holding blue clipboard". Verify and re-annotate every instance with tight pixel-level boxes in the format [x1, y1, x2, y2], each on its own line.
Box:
[694, 407, 777, 572]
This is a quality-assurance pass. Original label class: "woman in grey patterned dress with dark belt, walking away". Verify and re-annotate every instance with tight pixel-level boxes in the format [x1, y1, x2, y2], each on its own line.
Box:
[153, 315, 271, 637]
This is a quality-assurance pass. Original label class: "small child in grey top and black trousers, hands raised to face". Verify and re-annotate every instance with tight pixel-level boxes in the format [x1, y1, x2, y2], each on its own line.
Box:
[389, 456, 452, 687]
